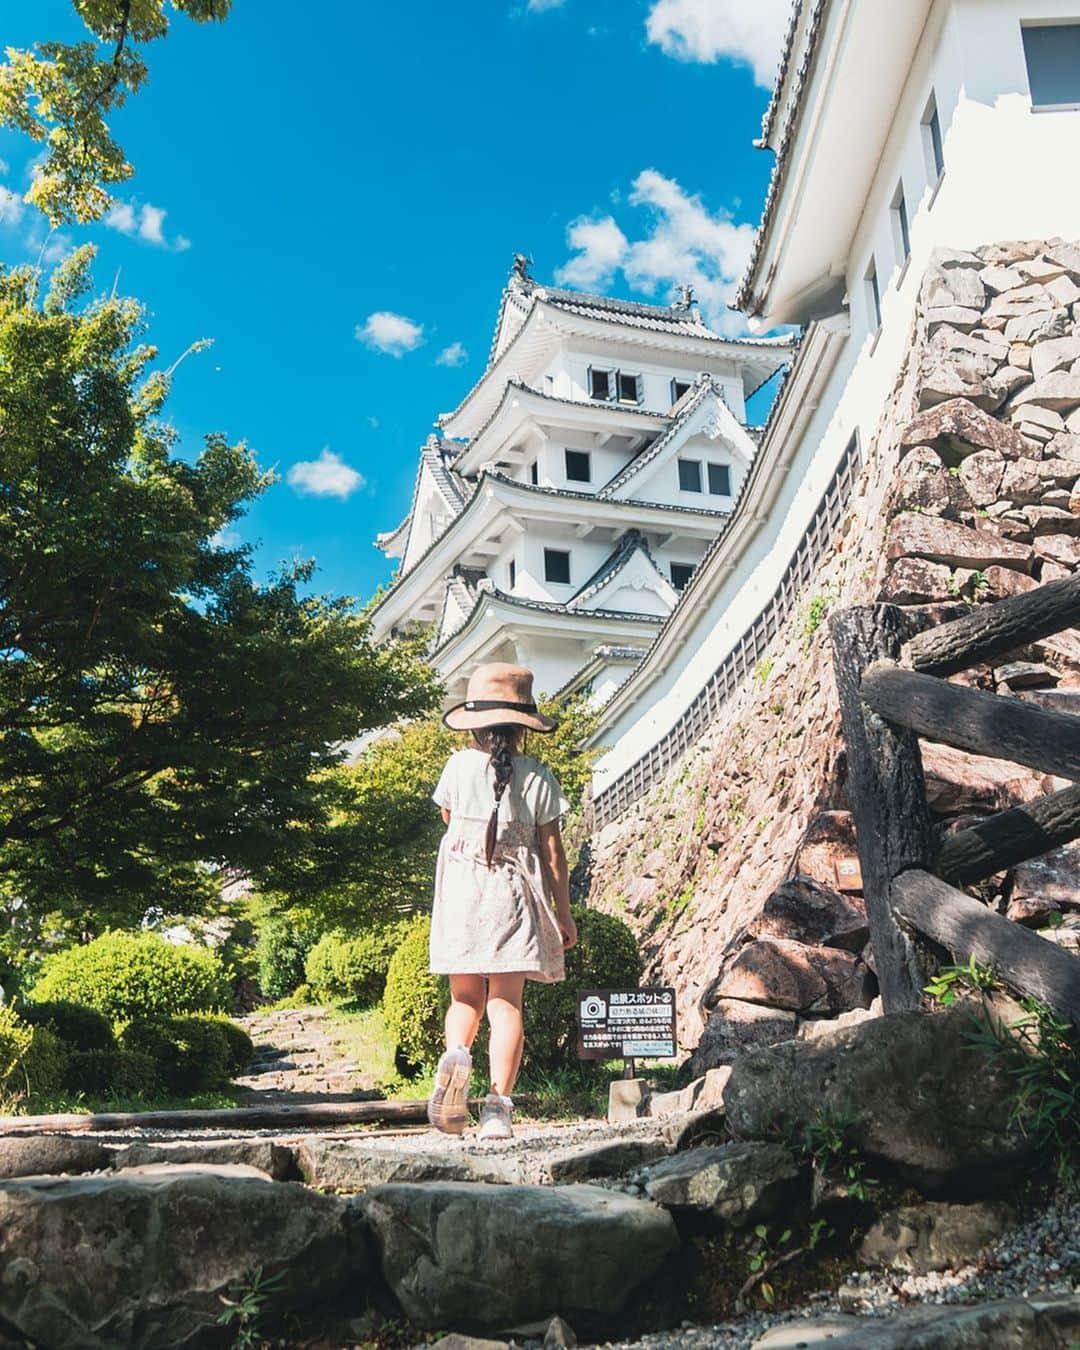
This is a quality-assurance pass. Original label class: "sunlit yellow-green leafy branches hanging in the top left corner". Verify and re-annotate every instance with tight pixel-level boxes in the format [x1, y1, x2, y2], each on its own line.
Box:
[0, 0, 232, 225]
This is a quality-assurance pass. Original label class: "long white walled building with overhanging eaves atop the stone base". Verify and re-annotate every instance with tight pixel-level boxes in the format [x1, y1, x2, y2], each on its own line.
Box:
[585, 0, 1080, 822]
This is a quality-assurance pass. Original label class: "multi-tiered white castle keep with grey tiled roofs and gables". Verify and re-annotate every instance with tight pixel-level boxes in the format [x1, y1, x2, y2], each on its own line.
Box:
[373, 259, 790, 701]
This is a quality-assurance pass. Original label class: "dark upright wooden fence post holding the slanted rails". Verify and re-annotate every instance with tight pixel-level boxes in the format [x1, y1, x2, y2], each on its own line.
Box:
[829, 605, 934, 1013]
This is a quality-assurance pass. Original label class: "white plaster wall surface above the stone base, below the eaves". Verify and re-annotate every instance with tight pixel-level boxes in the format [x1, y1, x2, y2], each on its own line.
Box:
[595, 0, 1080, 790]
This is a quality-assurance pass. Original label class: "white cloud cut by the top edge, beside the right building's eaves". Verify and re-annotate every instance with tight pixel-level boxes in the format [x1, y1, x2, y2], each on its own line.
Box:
[645, 0, 791, 89]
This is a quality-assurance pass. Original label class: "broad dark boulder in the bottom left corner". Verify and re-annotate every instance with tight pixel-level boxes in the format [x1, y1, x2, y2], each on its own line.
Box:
[0, 1166, 366, 1350]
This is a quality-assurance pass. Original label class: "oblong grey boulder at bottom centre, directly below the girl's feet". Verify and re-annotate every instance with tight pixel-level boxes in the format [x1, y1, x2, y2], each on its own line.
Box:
[352, 1181, 679, 1331]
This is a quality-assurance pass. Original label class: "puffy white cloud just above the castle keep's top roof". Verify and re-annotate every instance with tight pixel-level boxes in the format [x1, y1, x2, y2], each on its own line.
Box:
[555, 169, 753, 332]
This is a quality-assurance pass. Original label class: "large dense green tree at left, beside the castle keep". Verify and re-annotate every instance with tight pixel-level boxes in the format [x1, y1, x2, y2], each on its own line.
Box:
[0, 248, 437, 933]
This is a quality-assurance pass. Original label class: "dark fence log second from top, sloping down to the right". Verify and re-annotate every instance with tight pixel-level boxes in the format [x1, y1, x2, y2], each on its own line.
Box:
[861, 662, 1080, 779]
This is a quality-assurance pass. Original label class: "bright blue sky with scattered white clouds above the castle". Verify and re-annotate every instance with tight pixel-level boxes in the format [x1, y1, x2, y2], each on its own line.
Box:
[0, 0, 788, 598]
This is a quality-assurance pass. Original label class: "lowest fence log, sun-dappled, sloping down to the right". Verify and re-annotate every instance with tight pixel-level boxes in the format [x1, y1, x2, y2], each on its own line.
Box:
[892, 871, 1080, 1026]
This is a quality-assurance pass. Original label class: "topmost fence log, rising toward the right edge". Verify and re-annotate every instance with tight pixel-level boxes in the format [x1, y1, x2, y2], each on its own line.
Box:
[907, 572, 1080, 675]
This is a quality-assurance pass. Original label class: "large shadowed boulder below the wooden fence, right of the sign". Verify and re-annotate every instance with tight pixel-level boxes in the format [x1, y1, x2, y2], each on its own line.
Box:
[724, 1003, 1030, 1191]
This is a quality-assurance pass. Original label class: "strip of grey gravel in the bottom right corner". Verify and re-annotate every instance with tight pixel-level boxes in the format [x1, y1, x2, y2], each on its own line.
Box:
[597, 1196, 1080, 1350]
